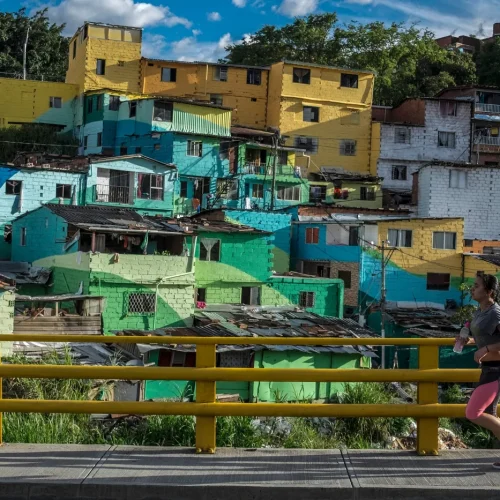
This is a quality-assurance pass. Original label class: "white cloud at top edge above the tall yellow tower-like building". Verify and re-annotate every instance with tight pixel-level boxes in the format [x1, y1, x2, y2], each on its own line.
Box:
[36, 0, 192, 35]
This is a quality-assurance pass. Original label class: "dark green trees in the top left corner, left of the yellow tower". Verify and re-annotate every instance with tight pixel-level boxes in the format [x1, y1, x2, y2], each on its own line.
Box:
[0, 8, 69, 81]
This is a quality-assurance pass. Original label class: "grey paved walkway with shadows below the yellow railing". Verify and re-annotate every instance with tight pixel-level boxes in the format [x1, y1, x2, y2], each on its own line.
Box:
[0, 445, 500, 500]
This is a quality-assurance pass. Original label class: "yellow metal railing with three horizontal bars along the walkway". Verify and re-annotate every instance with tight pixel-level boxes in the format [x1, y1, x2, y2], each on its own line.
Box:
[0, 334, 479, 455]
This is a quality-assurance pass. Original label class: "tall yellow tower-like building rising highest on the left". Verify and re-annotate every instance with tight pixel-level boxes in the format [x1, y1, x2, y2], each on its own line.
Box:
[66, 23, 142, 93]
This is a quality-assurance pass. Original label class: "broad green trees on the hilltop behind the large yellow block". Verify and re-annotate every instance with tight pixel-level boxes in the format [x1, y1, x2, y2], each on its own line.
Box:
[227, 13, 475, 105]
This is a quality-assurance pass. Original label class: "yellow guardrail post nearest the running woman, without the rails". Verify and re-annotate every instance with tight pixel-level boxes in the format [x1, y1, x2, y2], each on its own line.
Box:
[417, 345, 439, 455]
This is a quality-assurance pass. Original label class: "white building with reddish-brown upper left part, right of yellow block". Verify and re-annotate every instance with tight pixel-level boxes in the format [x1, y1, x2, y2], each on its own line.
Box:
[373, 98, 472, 193]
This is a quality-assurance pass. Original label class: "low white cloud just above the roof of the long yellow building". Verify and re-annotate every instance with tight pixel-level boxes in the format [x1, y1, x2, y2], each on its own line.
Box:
[143, 33, 234, 62]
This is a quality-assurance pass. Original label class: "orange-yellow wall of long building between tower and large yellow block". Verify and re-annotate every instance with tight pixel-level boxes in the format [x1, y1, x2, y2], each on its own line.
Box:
[142, 59, 268, 128]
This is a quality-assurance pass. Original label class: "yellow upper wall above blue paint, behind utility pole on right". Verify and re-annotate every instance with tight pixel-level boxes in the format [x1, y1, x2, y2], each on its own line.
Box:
[378, 219, 464, 277]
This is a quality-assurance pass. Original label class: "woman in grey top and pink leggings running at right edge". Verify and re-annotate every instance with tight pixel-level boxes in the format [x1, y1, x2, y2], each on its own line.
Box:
[464, 274, 500, 469]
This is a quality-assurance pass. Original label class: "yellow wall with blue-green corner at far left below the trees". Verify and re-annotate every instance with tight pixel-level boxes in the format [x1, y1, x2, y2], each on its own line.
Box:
[0, 78, 78, 128]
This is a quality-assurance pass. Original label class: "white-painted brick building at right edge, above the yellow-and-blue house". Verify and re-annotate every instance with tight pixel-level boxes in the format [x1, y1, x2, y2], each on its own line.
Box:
[414, 164, 500, 240]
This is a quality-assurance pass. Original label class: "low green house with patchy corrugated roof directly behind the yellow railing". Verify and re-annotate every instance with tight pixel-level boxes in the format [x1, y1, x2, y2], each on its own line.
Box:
[116, 306, 376, 402]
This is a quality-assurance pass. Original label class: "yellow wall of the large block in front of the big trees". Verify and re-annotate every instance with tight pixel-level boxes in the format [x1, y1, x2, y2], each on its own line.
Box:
[268, 63, 374, 173]
